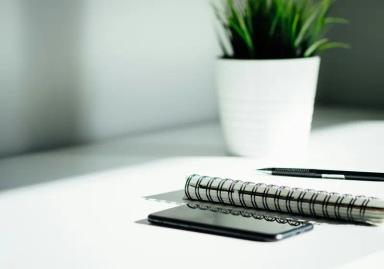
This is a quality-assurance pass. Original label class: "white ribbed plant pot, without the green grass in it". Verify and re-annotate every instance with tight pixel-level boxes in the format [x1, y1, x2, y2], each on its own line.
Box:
[216, 57, 320, 159]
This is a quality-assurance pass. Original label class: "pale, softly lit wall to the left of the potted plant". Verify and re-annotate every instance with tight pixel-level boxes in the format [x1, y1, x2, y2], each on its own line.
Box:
[0, 0, 218, 156]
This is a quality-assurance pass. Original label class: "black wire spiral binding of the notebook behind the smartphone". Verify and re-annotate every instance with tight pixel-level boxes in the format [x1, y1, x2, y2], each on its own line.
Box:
[184, 174, 384, 222]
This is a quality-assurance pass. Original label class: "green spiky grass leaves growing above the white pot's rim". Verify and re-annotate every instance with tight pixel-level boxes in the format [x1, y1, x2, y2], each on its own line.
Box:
[212, 0, 348, 59]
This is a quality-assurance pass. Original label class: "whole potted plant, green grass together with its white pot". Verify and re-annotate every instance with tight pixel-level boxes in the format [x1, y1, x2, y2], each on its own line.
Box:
[213, 0, 348, 157]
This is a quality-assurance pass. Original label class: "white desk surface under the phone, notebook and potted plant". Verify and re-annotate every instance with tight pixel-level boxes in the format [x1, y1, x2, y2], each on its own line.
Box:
[0, 105, 384, 269]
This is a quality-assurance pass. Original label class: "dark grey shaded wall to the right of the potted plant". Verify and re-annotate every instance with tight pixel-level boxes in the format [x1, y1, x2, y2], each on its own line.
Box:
[318, 0, 384, 108]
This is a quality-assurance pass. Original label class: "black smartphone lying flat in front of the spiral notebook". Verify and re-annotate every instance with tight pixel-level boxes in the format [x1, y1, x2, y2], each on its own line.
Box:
[148, 205, 313, 241]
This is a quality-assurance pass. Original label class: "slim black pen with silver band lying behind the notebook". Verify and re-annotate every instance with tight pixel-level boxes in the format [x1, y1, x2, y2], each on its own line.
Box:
[257, 167, 384, 181]
